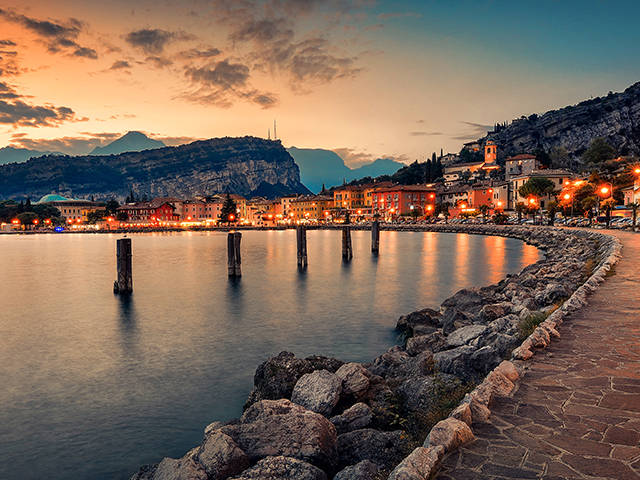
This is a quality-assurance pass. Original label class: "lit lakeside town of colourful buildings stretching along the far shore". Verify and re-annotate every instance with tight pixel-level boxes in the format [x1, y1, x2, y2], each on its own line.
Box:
[0, 139, 640, 232]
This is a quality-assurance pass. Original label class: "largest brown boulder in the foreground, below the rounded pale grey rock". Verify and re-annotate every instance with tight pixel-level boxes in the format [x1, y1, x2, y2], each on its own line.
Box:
[221, 399, 337, 470]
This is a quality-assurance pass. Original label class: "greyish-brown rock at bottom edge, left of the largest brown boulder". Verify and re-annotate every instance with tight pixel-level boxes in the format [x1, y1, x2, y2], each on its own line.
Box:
[195, 431, 249, 480]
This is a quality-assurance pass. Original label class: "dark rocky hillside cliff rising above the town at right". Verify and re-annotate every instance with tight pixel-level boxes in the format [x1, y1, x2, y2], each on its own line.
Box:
[480, 82, 640, 158]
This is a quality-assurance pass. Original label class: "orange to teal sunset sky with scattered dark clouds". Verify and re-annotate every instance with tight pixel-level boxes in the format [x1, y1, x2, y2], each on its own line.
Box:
[0, 0, 640, 166]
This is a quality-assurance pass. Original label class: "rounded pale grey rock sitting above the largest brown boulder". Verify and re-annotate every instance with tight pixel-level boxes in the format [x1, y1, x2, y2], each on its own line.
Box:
[291, 370, 342, 416]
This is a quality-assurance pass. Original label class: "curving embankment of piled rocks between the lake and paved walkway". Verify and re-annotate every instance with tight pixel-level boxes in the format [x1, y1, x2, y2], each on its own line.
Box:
[132, 225, 620, 480]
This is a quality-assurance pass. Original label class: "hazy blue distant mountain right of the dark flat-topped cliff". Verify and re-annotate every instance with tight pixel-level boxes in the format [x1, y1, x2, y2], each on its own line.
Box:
[287, 147, 404, 192]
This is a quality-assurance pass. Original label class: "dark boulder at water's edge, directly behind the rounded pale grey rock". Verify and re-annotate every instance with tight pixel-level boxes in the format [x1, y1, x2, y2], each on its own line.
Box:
[244, 352, 343, 409]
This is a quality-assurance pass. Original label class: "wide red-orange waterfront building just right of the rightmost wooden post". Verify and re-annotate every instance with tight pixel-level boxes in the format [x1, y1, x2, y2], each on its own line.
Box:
[372, 184, 436, 218]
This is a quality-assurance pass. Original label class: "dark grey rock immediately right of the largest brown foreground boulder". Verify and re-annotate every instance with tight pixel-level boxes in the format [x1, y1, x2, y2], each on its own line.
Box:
[338, 428, 409, 469]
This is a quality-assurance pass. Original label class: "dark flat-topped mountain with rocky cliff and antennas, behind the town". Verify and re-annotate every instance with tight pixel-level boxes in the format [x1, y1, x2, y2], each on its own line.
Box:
[0, 137, 309, 199]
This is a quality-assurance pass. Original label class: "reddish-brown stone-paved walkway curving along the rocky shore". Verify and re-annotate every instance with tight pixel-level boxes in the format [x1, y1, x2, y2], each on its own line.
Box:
[436, 232, 640, 480]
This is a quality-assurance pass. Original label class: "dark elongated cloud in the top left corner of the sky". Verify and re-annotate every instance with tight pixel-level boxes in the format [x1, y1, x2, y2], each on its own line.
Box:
[0, 8, 98, 59]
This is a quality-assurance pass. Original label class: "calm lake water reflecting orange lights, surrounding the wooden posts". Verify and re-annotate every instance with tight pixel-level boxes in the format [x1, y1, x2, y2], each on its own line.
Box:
[0, 231, 539, 480]
